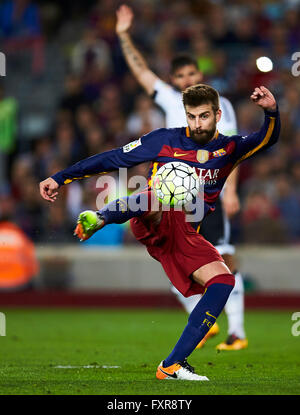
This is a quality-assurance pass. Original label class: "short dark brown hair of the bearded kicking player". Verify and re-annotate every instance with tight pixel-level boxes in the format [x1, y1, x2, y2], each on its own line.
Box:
[182, 84, 220, 112]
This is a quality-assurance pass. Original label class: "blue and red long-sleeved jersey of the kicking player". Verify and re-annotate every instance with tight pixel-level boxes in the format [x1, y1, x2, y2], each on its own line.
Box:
[52, 110, 280, 216]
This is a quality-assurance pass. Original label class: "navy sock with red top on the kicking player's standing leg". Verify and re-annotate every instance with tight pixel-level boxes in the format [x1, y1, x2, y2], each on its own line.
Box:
[163, 274, 234, 367]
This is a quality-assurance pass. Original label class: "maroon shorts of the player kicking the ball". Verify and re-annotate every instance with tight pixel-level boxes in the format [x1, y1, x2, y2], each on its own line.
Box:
[130, 210, 223, 297]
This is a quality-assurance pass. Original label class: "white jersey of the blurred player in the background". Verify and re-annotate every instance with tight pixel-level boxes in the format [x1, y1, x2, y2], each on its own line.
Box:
[154, 79, 237, 136]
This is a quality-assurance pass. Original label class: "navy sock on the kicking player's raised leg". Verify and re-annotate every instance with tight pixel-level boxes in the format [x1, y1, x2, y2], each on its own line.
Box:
[98, 191, 151, 225]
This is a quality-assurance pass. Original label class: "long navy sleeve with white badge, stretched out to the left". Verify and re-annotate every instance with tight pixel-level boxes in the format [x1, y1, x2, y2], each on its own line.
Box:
[51, 128, 166, 186]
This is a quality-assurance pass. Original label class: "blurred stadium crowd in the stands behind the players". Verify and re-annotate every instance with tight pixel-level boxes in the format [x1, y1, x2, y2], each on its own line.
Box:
[0, 0, 300, 245]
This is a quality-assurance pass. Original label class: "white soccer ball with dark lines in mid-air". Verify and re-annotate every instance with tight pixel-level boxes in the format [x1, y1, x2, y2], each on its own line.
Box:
[152, 161, 200, 206]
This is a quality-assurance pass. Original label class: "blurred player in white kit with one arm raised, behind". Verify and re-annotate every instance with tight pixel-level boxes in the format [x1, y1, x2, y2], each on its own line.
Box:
[116, 5, 248, 350]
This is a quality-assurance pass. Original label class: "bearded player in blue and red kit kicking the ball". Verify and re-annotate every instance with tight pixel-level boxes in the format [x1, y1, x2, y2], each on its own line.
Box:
[40, 84, 280, 381]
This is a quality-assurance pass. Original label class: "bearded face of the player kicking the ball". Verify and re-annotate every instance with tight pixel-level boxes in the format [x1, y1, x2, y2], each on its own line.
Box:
[185, 104, 221, 145]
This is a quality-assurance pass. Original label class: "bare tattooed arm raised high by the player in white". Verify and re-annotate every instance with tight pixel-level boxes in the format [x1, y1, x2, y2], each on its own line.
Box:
[116, 4, 159, 95]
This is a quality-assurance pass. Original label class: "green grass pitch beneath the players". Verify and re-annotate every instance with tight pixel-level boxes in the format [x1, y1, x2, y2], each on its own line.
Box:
[0, 309, 300, 396]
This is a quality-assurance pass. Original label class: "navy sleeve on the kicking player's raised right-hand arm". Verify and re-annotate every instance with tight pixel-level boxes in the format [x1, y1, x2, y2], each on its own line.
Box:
[233, 109, 280, 165]
